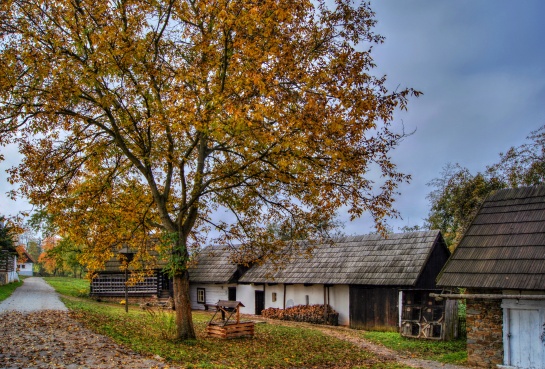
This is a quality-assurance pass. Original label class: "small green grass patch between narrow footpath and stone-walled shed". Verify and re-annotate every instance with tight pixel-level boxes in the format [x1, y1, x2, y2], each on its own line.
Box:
[359, 331, 467, 365]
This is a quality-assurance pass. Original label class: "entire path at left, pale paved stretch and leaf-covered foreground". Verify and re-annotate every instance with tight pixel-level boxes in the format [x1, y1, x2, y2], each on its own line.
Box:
[0, 278, 174, 369]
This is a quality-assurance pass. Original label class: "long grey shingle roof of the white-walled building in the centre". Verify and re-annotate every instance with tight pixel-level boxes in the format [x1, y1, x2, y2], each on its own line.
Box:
[239, 231, 444, 286]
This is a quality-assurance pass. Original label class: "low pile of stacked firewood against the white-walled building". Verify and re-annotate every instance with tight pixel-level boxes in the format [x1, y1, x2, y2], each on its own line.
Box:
[261, 305, 339, 325]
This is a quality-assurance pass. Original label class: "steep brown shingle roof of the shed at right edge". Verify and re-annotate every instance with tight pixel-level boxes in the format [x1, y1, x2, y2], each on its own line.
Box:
[438, 186, 545, 290]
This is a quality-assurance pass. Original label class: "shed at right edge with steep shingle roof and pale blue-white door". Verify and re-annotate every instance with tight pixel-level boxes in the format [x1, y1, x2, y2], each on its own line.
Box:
[438, 186, 545, 369]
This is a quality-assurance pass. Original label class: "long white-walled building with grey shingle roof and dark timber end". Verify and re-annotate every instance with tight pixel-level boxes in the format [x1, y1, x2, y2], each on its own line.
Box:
[239, 231, 451, 339]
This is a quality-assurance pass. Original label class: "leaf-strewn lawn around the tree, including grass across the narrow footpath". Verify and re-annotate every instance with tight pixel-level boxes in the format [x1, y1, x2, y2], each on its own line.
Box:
[46, 278, 465, 369]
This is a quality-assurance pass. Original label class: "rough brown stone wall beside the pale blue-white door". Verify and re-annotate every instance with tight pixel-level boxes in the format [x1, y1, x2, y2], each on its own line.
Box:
[466, 291, 503, 368]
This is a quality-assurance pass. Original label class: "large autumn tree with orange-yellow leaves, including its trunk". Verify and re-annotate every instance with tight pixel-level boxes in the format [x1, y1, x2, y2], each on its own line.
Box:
[0, 0, 418, 338]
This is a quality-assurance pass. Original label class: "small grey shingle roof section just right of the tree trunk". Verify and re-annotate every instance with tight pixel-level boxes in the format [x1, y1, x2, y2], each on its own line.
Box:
[189, 246, 239, 283]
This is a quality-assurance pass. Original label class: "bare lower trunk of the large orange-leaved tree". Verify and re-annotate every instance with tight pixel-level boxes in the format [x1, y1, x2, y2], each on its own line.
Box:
[174, 270, 197, 340]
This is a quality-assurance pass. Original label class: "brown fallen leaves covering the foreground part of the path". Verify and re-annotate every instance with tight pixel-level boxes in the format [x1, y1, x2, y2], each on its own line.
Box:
[0, 311, 174, 369]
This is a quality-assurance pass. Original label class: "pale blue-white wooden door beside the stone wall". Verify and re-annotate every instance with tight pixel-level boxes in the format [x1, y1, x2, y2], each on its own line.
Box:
[502, 300, 545, 369]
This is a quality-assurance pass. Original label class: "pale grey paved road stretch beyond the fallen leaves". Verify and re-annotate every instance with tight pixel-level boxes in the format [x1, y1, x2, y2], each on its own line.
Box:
[0, 277, 68, 313]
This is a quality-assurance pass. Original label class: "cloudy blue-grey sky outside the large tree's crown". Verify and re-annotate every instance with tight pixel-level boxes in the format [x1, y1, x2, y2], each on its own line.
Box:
[0, 0, 545, 234]
